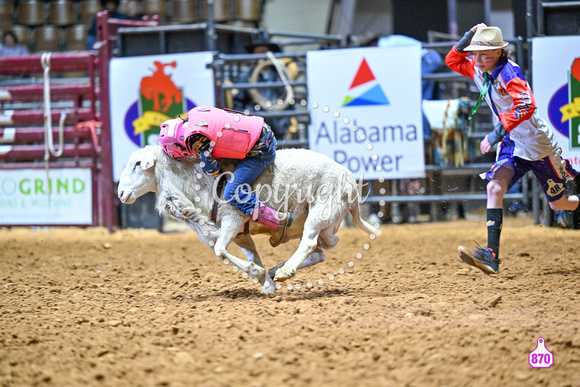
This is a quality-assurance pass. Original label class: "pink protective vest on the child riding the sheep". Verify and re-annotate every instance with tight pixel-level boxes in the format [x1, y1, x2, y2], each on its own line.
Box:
[187, 106, 264, 160]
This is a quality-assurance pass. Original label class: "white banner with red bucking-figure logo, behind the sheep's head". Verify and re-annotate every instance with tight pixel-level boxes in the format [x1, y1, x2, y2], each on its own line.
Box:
[110, 52, 215, 181]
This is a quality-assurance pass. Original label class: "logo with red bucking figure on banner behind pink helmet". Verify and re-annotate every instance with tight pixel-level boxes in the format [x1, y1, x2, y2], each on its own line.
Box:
[124, 61, 195, 147]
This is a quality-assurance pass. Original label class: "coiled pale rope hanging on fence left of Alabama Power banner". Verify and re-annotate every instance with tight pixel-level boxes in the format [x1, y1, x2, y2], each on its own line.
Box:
[248, 51, 294, 111]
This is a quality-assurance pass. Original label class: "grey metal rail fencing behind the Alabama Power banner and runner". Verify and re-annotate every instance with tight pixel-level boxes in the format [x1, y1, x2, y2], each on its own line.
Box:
[213, 35, 549, 223]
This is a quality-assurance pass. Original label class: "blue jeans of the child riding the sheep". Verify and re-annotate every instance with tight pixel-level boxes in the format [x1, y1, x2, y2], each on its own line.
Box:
[224, 140, 276, 215]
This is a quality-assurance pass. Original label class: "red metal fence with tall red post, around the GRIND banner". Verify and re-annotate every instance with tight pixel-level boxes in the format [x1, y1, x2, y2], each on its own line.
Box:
[0, 12, 157, 230]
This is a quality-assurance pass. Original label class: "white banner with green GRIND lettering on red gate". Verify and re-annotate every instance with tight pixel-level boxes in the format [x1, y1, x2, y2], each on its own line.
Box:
[0, 168, 93, 226]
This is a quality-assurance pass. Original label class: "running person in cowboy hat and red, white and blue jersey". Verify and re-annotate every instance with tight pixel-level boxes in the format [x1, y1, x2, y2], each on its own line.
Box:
[445, 23, 580, 274]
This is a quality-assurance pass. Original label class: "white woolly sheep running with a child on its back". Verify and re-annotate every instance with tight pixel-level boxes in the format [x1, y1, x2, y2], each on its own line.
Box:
[118, 146, 380, 294]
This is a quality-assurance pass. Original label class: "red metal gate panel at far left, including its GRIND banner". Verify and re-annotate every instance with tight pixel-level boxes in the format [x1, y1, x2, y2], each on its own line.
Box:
[0, 52, 103, 226]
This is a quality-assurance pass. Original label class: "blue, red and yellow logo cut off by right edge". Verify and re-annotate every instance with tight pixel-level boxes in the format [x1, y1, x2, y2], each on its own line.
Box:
[548, 58, 580, 149]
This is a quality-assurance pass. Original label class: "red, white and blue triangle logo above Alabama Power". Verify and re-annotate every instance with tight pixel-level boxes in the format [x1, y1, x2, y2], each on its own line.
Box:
[342, 58, 389, 106]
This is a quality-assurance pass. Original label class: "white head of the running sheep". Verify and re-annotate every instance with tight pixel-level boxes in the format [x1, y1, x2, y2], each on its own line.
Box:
[117, 146, 159, 204]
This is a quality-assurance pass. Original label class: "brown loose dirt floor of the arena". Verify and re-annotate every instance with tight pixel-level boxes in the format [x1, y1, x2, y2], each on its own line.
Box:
[0, 218, 580, 386]
